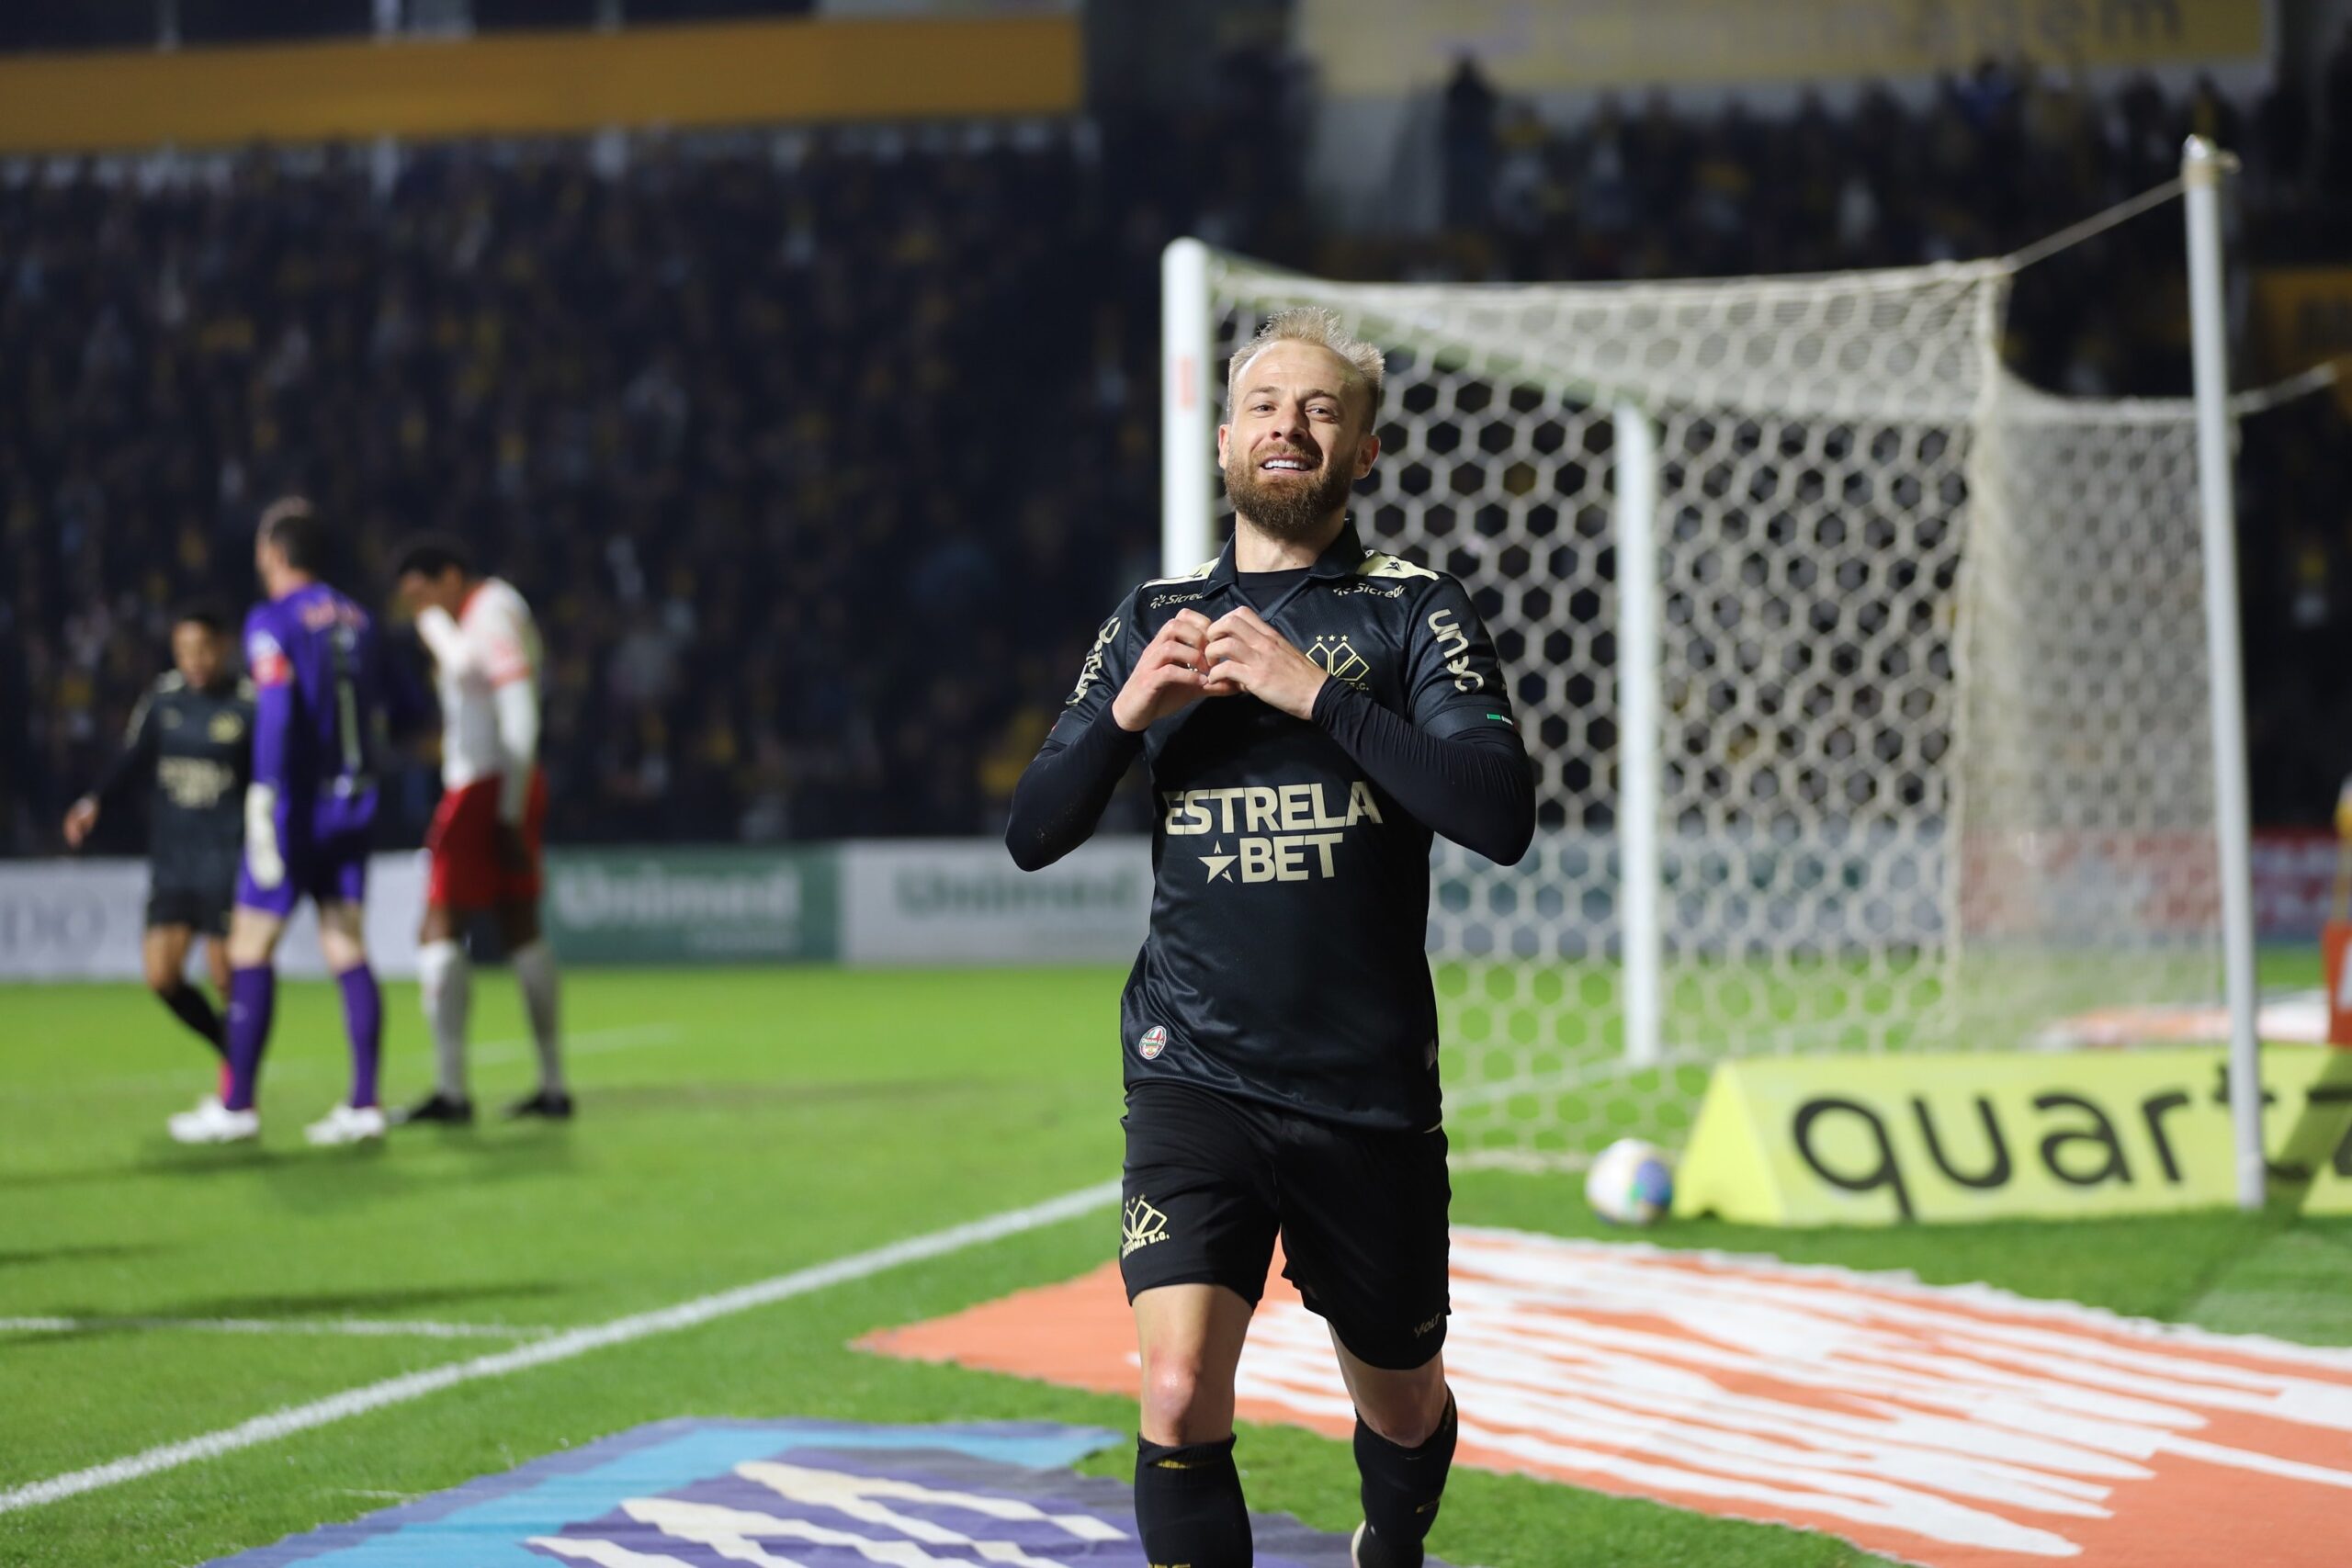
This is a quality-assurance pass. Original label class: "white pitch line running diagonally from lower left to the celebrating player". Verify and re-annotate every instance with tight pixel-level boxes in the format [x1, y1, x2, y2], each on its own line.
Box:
[0, 1180, 1120, 1514]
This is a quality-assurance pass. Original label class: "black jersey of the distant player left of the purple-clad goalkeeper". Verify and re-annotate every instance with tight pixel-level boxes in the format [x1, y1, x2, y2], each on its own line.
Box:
[92, 670, 254, 886]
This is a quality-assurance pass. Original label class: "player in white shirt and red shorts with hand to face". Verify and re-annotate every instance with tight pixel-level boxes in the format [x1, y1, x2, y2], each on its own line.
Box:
[398, 538, 571, 1123]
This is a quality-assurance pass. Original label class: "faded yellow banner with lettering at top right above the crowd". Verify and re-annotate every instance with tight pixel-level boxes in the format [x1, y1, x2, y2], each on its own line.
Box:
[1301, 0, 2269, 96]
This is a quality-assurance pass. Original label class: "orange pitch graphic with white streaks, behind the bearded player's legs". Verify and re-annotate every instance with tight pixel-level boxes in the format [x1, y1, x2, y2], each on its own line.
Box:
[864, 1229, 2352, 1568]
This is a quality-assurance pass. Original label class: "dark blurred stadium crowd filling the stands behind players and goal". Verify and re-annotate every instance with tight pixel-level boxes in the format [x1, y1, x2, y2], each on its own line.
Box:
[0, 42, 2352, 853]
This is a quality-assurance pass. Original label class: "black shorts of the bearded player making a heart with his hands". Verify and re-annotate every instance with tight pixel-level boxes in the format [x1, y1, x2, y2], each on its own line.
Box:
[1120, 1084, 1453, 1371]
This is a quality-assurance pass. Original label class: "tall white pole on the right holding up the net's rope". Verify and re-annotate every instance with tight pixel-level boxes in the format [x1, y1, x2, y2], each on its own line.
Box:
[2180, 136, 2267, 1208]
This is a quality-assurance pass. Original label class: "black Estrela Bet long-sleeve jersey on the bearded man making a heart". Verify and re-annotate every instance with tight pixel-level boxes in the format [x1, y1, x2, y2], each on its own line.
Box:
[1007, 526, 1533, 1128]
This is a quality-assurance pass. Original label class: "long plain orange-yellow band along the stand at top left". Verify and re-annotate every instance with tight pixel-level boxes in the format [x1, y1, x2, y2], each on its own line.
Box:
[0, 14, 1084, 152]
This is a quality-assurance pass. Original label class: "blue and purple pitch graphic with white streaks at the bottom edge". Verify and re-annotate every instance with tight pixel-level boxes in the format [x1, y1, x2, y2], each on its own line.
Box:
[214, 1420, 1444, 1568]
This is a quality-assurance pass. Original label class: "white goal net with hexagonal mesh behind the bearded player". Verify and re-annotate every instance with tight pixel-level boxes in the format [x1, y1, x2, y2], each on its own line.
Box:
[1169, 243, 2222, 1164]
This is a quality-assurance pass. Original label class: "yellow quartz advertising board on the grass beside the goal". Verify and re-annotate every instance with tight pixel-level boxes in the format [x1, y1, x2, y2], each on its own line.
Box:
[1675, 1046, 2352, 1224]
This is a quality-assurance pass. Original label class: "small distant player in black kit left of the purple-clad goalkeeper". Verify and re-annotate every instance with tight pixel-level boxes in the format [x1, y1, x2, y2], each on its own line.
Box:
[66, 606, 254, 1081]
